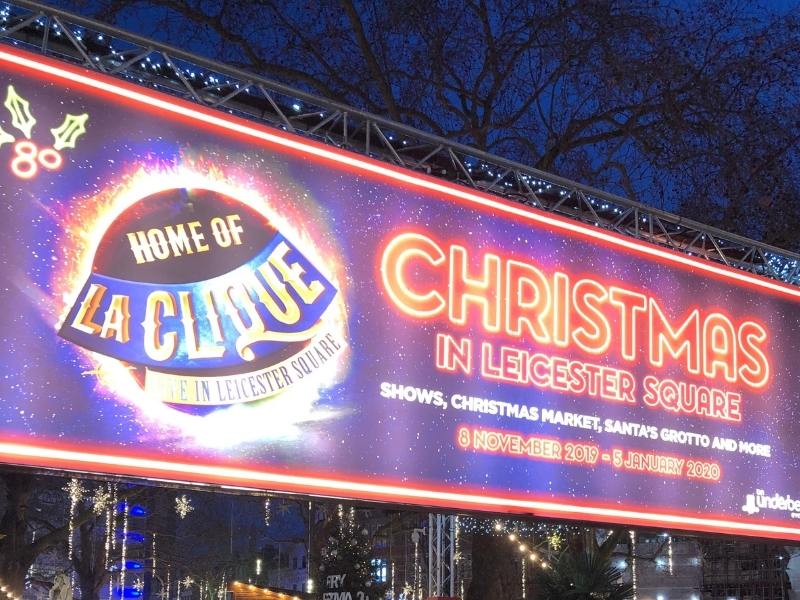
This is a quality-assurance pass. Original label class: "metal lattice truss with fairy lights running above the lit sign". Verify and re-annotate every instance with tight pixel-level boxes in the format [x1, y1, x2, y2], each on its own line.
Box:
[0, 0, 800, 285]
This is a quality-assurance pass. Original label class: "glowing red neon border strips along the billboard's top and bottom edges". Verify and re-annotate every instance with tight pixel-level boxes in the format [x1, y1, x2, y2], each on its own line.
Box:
[0, 47, 800, 541]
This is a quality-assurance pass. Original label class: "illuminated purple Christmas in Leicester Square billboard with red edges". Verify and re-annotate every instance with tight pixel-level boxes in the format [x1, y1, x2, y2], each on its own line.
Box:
[0, 48, 800, 540]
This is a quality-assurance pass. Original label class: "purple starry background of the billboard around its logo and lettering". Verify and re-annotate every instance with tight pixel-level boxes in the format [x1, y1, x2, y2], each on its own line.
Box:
[0, 49, 800, 539]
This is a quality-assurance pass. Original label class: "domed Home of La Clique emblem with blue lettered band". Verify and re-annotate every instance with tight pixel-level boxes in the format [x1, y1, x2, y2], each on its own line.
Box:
[59, 188, 345, 412]
